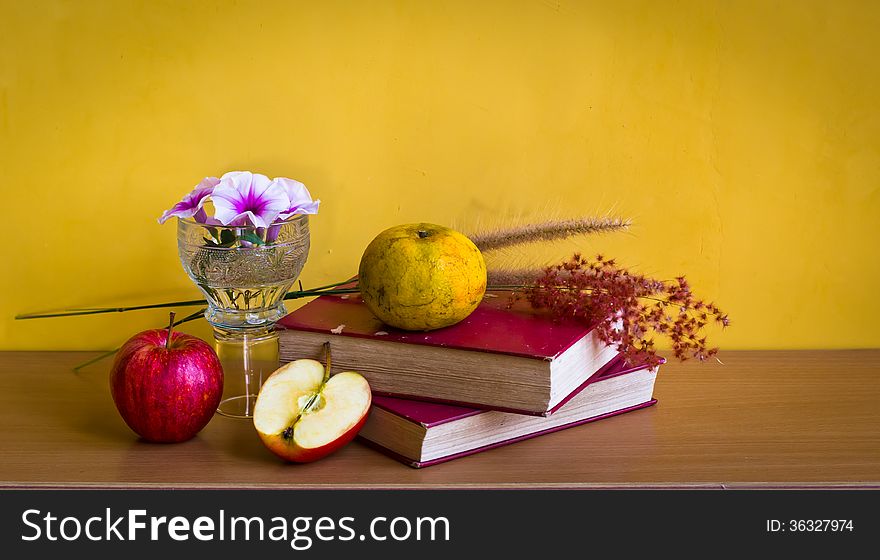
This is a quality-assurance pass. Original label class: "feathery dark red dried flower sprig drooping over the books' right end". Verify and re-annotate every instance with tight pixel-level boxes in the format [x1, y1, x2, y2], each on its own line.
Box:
[525, 254, 730, 366]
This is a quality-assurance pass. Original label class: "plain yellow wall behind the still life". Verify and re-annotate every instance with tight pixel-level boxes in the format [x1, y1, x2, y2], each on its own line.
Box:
[0, 0, 880, 349]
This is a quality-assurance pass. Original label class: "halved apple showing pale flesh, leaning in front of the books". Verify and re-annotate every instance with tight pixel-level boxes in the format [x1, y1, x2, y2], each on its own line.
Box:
[254, 360, 372, 463]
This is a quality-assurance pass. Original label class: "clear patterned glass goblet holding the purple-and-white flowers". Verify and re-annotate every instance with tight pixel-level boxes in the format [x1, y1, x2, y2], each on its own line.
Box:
[177, 214, 309, 418]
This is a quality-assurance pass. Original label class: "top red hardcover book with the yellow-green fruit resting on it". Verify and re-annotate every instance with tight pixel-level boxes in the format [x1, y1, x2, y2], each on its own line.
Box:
[279, 293, 617, 415]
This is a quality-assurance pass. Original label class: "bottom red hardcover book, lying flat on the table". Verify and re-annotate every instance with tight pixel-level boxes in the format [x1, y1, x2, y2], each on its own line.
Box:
[358, 357, 657, 468]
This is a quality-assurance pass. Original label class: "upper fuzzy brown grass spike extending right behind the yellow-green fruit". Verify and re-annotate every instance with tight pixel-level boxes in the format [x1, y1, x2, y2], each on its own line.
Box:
[469, 217, 630, 251]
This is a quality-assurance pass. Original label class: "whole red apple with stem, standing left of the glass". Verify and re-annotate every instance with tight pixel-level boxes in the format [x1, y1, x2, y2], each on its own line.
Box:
[110, 315, 223, 443]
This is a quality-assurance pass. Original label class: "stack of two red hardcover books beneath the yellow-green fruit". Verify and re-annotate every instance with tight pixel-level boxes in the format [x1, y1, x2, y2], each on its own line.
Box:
[279, 294, 657, 467]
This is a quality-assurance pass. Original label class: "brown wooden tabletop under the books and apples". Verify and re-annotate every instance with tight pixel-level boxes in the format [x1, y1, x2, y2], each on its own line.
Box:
[0, 350, 880, 488]
